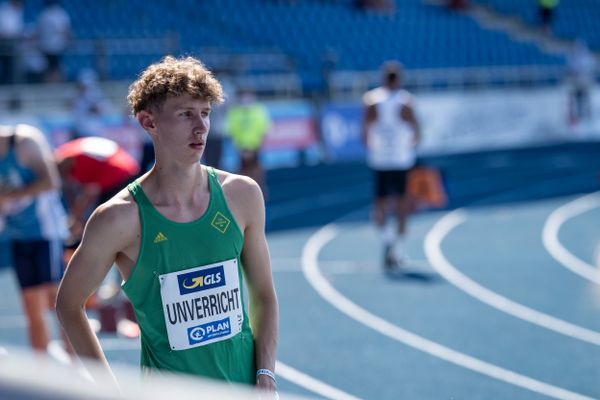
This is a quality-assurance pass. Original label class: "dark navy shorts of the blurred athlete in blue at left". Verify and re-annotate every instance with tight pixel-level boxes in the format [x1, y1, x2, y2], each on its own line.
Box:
[12, 240, 64, 289]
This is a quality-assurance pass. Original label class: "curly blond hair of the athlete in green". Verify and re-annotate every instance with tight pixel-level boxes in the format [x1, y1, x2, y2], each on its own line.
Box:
[127, 56, 223, 115]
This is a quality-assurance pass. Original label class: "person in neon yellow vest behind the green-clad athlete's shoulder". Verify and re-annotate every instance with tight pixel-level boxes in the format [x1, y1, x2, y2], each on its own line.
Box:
[226, 89, 271, 195]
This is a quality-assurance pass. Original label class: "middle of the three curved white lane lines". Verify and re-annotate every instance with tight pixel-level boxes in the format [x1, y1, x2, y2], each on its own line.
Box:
[425, 210, 600, 346]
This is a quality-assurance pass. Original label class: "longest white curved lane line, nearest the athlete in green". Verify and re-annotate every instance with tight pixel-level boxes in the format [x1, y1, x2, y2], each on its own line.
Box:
[302, 225, 592, 400]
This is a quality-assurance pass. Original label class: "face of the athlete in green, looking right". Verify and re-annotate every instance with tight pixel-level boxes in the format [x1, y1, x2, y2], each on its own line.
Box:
[142, 94, 211, 161]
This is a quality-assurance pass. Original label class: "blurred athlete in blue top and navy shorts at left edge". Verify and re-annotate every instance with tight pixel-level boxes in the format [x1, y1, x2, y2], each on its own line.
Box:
[0, 125, 70, 352]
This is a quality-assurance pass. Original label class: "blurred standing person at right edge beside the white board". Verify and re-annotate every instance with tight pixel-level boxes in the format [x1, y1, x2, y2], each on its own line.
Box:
[567, 41, 597, 123]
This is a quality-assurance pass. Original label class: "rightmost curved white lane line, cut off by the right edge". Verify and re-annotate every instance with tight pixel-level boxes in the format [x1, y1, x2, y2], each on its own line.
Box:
[542, 192, 600, 285]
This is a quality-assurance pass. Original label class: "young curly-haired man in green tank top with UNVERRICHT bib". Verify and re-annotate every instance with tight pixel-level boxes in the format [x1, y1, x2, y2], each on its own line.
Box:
[57, 56, 278, 391]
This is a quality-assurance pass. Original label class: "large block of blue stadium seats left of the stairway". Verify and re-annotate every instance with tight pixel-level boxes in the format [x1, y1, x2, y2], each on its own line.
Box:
[16, 0, 564, 92]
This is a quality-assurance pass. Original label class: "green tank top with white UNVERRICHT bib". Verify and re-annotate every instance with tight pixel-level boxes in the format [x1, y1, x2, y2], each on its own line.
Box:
[122, 168, 256, 384]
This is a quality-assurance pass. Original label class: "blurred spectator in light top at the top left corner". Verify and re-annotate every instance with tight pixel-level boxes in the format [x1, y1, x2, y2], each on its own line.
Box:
[0, 0, 25, 84]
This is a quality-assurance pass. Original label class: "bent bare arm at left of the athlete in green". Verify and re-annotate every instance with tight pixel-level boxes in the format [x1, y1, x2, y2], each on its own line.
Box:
[56, 199, 134, 388]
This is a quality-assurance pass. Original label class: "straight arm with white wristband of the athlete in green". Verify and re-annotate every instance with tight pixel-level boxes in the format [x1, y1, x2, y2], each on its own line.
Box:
[235, 177, 279, 390]
